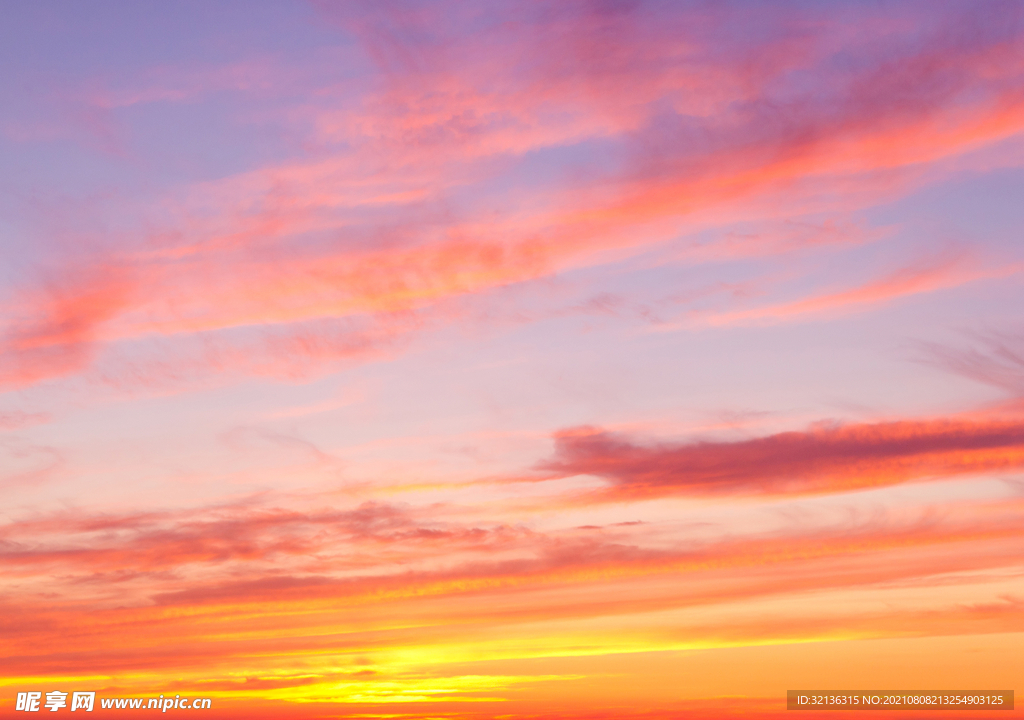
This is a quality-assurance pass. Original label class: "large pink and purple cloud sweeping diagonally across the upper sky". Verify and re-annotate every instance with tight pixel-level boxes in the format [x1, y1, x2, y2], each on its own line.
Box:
[0, 3, 1024, 393]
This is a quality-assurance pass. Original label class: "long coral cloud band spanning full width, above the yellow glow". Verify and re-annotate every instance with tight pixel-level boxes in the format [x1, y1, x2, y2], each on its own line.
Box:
[0, 487, 1021, 613]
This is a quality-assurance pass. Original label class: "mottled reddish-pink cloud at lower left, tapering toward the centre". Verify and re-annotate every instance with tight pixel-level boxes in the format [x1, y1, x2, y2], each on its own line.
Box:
[0, 502, 532, 594]
